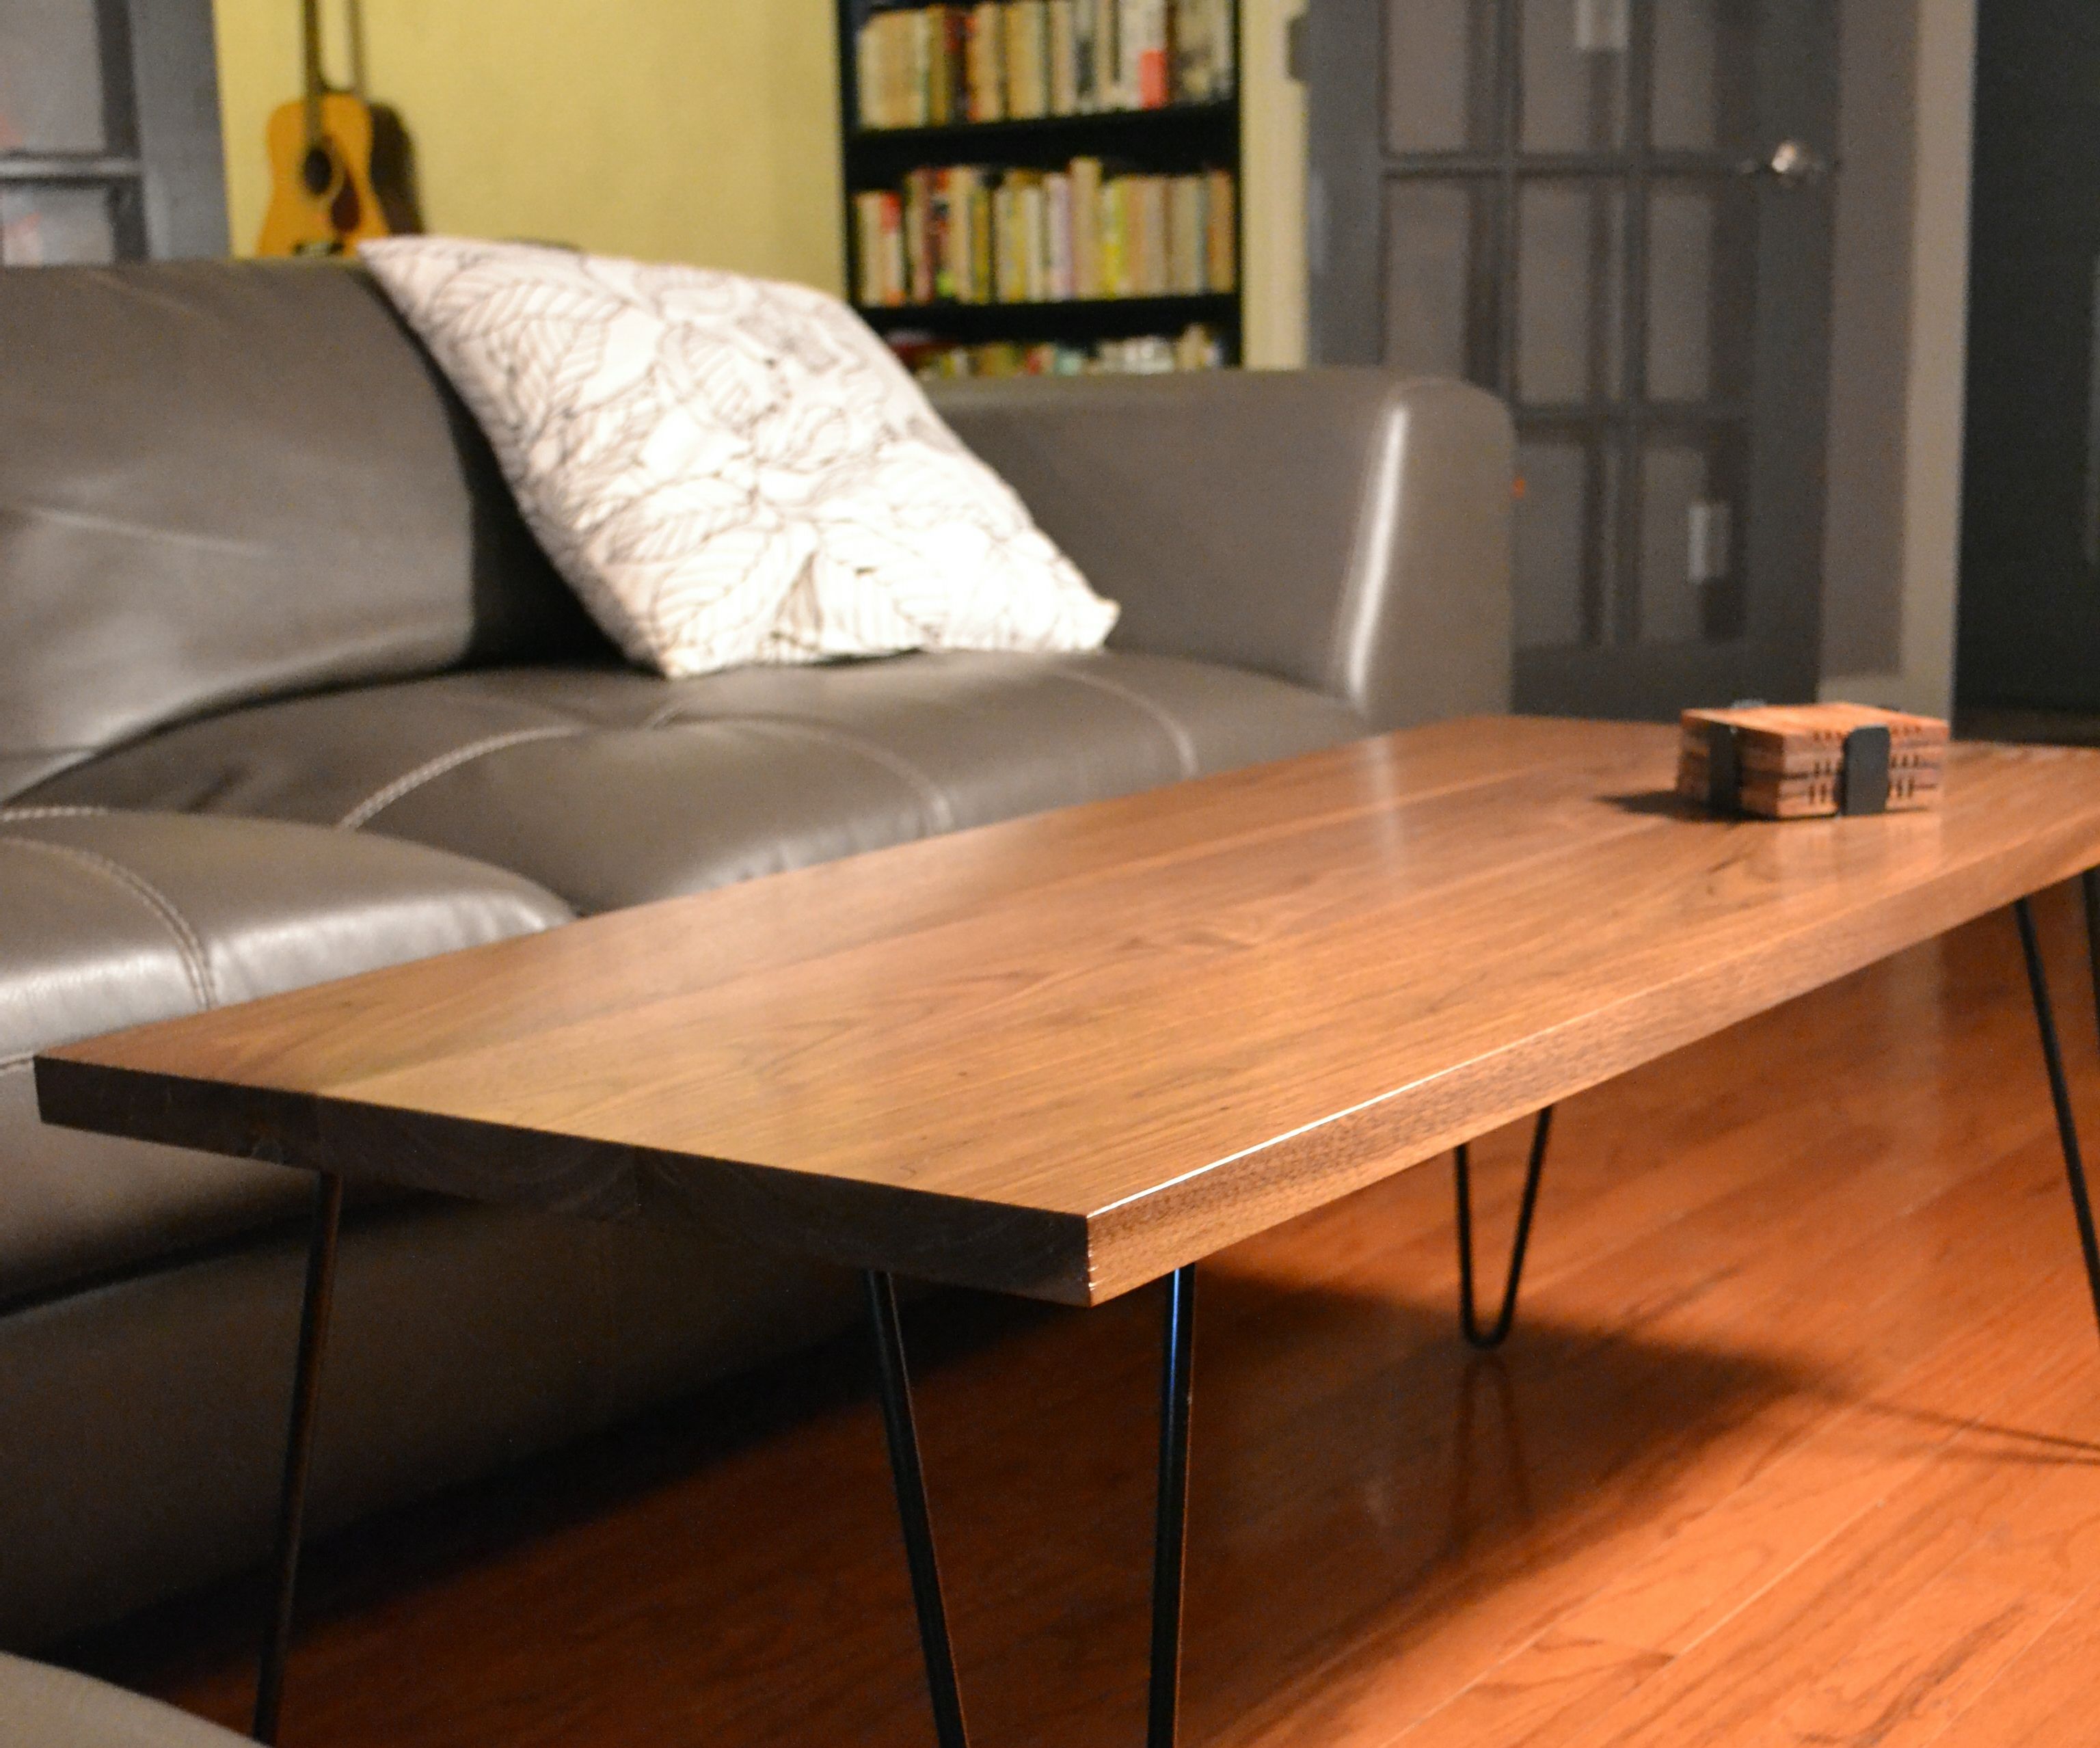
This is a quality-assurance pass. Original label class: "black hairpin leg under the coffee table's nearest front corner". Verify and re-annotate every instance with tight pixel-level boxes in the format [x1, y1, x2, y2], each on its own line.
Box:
[867, 1263, 1195, 1748]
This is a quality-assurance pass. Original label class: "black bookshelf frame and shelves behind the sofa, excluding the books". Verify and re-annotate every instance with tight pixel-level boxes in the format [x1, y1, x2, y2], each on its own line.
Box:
[838, 0, 1248, 364]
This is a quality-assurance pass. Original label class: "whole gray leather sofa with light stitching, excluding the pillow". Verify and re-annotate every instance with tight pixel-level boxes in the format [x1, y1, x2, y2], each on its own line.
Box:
[0, 263, 1510, 1647]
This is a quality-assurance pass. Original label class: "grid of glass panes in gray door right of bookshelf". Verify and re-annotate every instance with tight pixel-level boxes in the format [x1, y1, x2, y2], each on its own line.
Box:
[1382, 0, 1755, 647]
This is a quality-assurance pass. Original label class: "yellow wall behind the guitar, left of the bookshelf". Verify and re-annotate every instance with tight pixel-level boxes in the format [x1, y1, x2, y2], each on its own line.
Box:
[214, 0, 842, 290]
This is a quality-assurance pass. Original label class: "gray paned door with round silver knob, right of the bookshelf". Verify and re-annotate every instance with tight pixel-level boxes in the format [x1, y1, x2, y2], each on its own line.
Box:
[1300, 0, 1838, 716]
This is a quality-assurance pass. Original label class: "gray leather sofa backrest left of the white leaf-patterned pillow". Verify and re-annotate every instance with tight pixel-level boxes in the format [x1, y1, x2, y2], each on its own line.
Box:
[0, 263, 605, 796]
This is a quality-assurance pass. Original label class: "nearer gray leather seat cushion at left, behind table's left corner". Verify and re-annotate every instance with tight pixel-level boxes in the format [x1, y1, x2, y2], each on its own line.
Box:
[0, 807, 569, 1305]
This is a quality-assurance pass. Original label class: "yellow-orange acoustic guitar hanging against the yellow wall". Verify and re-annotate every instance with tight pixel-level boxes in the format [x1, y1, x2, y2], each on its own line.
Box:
[256, 0, 422, 254]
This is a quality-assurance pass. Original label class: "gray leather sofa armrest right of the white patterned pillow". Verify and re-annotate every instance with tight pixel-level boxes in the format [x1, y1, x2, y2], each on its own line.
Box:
[934, 370, 1514, 729]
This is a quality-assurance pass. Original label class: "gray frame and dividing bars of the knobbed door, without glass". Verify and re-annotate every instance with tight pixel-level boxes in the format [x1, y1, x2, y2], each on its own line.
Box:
[1300, 0, 1838, 716]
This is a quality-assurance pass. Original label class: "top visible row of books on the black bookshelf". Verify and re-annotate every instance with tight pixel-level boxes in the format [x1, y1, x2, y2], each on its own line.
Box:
[854, 0, 1235, 128]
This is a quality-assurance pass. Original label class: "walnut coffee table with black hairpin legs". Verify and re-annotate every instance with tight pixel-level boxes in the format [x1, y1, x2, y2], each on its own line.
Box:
[36, 718, 2100, 1748]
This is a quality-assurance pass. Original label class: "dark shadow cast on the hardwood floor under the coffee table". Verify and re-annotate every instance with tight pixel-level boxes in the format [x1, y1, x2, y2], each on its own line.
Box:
[57, 1254, 1827, 1748]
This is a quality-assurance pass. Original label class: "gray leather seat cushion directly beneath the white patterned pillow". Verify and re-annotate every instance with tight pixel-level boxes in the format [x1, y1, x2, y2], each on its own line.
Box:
[25, 651, 1367, 912]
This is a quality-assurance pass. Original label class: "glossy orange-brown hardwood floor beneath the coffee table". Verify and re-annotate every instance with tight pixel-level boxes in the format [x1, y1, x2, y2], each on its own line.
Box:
[76, 893, 2100, 1748]
